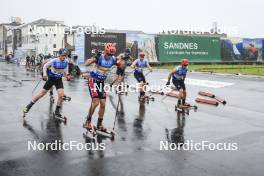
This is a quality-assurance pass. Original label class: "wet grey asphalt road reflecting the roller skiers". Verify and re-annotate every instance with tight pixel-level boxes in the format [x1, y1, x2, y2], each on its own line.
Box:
[0, 63, 264, 176]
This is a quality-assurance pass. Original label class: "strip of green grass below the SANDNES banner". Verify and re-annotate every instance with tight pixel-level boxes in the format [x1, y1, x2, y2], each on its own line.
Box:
[156, 64, 264, 76]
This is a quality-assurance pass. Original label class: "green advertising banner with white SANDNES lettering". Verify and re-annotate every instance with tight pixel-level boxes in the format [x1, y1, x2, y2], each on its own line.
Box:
[158, 35, 221, 62]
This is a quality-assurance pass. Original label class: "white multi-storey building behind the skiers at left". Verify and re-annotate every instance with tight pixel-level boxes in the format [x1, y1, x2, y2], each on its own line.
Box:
[15, 19, 68, 57]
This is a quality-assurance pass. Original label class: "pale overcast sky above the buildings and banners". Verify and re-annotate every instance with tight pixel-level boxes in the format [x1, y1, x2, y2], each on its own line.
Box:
[0, 0, 264, 38]
